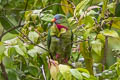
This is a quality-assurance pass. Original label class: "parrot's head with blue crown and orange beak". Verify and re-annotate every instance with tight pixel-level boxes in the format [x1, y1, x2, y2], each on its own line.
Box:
[51, 14, 67, 24]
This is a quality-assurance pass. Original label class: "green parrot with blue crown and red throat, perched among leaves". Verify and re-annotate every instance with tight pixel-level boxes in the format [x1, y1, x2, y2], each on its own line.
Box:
[47, 14, 73, 63]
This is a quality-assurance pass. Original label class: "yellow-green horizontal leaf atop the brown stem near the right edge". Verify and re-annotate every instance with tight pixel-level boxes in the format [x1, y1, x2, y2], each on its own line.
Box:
[100, 29, 119, 38]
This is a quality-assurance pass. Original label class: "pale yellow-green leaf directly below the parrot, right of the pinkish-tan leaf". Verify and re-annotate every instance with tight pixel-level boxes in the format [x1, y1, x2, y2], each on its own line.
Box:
[59, 64, 72, 80]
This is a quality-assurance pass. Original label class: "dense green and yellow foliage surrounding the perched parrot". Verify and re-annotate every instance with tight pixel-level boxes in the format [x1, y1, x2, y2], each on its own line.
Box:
[0, 0, 120, 80]
